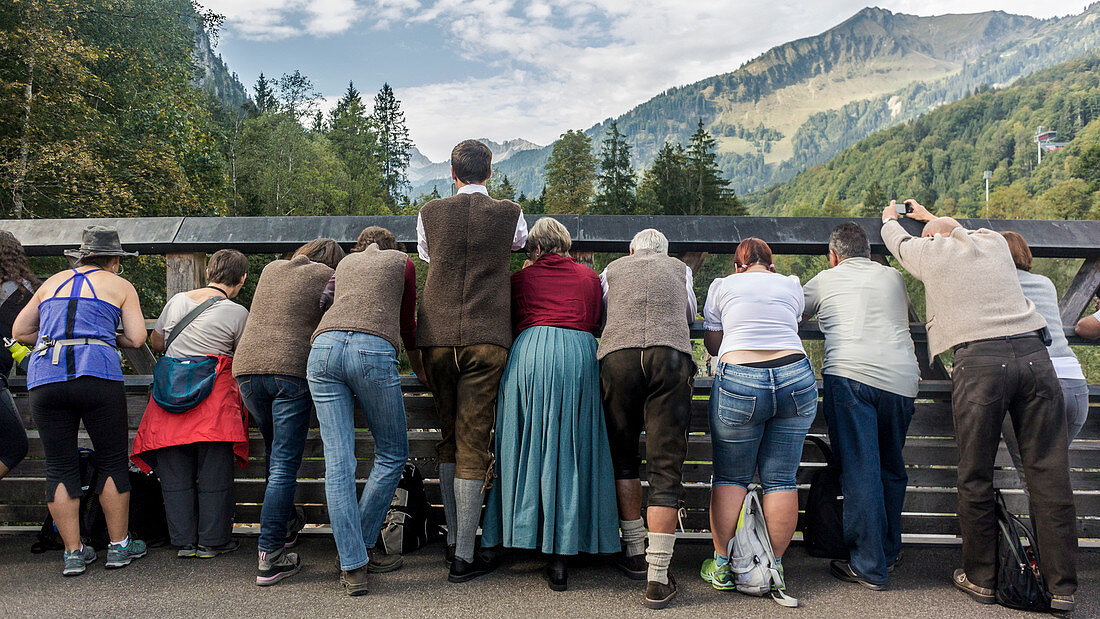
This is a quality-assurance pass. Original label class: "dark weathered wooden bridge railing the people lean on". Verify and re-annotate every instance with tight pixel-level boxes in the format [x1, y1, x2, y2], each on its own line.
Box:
[0, 215, 1100, 539]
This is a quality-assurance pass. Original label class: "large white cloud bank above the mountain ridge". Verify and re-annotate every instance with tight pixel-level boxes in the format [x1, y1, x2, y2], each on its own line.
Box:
[367, 0, 1081, 161]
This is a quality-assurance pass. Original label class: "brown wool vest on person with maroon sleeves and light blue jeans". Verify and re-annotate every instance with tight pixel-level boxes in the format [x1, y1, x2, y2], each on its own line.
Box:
[314, 244, 408, 351]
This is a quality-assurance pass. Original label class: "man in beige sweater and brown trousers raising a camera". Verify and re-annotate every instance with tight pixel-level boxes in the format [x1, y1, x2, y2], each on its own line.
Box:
[881, 200, 1077, 610]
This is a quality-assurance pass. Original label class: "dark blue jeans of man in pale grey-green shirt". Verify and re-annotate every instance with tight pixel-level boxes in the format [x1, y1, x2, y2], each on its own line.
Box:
[822, 374, 913, 585]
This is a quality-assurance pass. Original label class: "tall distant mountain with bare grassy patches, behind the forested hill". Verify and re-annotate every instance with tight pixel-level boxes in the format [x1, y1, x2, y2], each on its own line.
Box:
[484, 4, 1100, 199]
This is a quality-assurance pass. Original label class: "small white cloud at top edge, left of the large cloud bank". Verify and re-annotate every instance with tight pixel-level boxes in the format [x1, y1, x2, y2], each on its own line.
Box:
[202, 0, 363, 41]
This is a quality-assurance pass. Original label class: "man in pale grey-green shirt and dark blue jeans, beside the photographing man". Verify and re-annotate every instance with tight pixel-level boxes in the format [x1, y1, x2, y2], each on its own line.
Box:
[802, 223, 921, 590]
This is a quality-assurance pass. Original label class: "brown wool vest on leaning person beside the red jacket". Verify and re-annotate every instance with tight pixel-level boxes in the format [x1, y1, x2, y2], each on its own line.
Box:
[233, 256, 332, 378]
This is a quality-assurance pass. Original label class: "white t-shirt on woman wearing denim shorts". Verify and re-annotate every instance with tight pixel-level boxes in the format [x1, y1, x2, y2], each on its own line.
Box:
[703, 273, 805, 360]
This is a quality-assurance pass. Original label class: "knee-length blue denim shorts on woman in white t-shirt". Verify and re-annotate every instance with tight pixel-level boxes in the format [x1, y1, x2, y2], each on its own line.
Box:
[710, 358, 817, 494]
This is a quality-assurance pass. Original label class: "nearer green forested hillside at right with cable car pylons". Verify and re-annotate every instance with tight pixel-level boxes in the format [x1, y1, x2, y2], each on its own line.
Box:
[745, 54, 1100, 218]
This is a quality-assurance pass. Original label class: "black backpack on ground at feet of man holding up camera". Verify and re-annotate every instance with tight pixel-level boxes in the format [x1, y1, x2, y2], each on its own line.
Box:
[993, 490, 1051, 611]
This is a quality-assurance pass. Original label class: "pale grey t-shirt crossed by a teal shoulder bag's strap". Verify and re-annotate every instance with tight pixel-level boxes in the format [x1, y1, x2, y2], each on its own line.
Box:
[153, 292, 249, 358]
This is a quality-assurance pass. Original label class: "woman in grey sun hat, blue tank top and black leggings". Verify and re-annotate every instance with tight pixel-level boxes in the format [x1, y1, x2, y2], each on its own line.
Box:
[12, 225, 145, 576]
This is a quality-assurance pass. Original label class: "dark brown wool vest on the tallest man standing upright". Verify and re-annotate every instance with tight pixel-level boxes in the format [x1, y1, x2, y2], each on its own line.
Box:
[417, 194, 519, 347]
